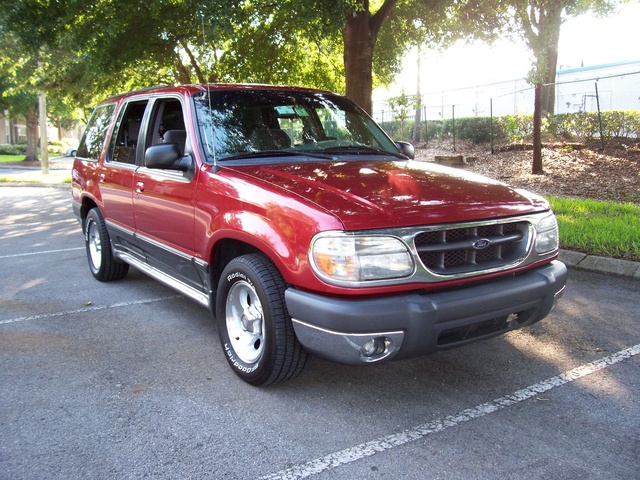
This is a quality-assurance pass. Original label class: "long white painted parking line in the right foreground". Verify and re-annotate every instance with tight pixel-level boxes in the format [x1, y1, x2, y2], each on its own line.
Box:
[260, 344, 640, 480]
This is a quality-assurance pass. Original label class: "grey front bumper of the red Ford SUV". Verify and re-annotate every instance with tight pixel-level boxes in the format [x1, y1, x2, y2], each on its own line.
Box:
[285, 261, 567, 364]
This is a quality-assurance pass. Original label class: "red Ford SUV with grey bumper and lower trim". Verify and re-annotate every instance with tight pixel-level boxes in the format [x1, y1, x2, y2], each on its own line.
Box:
[72, 85, 567, 385]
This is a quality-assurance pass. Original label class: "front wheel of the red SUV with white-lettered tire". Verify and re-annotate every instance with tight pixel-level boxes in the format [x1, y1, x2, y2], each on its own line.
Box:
[216, 254, 307, 386]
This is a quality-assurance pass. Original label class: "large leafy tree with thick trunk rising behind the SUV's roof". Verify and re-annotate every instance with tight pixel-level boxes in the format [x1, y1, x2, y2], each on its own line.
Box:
[0, 0, 524, 129]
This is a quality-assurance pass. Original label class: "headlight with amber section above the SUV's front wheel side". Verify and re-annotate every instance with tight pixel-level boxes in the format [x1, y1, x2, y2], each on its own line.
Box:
[311, 232, 414, 284]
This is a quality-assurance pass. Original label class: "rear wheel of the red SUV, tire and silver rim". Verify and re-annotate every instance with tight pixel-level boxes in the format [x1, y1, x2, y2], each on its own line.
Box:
[84, 208, 129, 282]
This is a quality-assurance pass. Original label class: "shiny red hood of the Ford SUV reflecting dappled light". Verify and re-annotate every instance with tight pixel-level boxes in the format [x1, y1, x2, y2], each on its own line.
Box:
[226, 160, 549, 230]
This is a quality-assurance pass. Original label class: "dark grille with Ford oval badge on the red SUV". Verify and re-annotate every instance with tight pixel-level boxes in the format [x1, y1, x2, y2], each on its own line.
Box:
[414, 222, 530, 275]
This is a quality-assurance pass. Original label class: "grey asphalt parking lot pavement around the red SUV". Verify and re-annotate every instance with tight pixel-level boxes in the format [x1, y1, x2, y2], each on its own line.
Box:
[0, 187, 640, 480]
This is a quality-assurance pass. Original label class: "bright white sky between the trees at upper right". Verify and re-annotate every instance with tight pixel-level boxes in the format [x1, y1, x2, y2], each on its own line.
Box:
[374, 2, 640, 101]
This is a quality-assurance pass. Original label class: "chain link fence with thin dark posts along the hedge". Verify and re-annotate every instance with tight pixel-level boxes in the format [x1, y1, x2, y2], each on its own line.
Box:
[373, 61, 640, 151]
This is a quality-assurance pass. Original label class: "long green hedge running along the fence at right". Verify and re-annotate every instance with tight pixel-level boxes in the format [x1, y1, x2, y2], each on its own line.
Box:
[381, 110, 640, 143]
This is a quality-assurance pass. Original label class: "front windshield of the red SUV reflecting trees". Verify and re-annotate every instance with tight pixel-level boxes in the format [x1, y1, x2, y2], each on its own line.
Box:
[194, 89, 404, 161]
